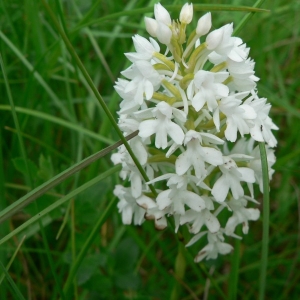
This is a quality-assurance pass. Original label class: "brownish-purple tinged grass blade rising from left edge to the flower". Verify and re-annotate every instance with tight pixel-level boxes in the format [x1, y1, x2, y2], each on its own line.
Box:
[0, 131, 138, 223]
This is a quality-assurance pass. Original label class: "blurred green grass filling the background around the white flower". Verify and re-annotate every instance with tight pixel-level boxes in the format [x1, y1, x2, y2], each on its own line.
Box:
[0, 0, 300, 300]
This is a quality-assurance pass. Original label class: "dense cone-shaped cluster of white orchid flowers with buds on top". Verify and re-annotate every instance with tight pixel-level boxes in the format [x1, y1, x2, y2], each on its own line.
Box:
[112, 4, 278, 262]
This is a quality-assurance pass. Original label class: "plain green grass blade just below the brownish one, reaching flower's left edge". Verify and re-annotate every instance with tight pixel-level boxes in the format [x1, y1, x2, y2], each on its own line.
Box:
[0, 166, 121, 245]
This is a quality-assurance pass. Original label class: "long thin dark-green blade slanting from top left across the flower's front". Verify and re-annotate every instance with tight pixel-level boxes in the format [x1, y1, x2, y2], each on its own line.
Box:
[42, 0, 157, 195]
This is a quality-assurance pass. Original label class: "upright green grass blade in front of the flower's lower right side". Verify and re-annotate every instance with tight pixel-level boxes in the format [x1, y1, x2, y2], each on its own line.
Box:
[259, 143, 270, 300]
